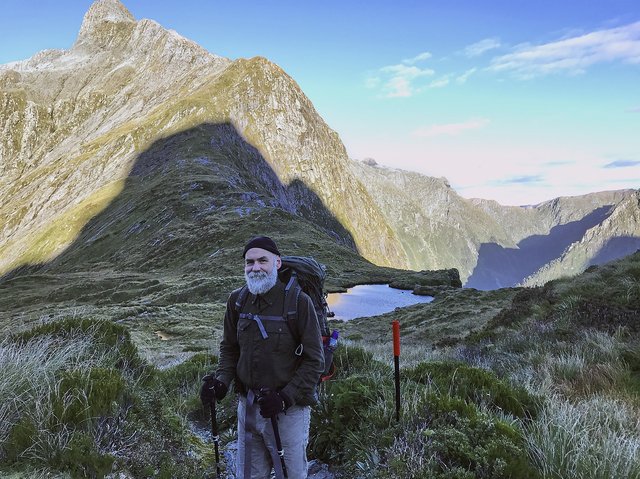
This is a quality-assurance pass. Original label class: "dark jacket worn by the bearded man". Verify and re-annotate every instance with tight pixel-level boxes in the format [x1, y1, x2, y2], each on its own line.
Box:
[216, 281, 324, 405]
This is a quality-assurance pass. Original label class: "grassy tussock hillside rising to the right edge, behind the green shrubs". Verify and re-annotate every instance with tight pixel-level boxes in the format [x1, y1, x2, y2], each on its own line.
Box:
[319, 253, 640, 479]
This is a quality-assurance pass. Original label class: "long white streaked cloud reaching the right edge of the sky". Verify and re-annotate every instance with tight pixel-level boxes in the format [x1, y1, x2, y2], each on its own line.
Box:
[490, 22, 640, 78]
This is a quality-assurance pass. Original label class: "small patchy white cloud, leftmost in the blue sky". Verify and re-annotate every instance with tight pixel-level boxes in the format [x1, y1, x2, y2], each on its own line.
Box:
[365, 52, 435, 98]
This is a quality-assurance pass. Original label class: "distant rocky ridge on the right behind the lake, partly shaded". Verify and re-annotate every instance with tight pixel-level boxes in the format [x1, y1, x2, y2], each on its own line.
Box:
[351, 161, 640, 289]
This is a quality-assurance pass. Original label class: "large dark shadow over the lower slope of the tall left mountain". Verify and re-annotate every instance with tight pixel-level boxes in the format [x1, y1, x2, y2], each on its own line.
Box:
[0, 123, 357, 310]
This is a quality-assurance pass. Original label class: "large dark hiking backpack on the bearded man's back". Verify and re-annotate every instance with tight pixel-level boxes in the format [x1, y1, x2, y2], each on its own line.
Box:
[235, 256, 338, 382]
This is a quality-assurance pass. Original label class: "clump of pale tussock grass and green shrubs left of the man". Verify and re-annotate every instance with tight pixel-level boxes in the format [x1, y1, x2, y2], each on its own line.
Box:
[0, 318, 222, 478]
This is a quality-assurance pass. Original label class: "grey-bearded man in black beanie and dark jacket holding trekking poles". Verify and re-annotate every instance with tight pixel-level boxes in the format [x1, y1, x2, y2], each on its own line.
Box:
[200, 236, 324, 479]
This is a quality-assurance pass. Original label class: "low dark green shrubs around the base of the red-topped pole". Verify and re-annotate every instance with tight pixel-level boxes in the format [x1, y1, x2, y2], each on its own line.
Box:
[311, 347, 538, 478]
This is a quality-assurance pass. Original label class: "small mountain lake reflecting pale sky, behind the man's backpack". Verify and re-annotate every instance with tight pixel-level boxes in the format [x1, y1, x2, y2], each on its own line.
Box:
[327, 284, 433, 321]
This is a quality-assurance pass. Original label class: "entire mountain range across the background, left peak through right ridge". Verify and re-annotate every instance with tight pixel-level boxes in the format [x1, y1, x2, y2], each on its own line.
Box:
[0, 0, 640, 289]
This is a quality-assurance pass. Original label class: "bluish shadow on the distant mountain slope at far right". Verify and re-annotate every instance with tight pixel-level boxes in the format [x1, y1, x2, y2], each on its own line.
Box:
[465, 205, 612, 290]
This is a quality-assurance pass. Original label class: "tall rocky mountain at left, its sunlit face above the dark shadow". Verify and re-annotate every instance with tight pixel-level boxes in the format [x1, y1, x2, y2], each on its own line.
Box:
[0, 0, 403, 282]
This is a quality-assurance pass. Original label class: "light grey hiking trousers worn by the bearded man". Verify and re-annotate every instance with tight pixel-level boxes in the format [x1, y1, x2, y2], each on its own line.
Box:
[236, 396, 311, 479]
